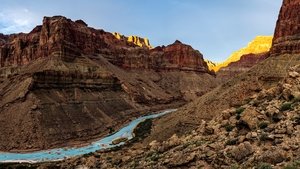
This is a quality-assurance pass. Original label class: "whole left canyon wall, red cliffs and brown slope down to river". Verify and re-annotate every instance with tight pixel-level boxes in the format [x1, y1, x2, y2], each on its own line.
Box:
[0, 16, 216, 151]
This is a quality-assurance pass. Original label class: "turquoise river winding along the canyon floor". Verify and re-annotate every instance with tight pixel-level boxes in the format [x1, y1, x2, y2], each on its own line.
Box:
[0, 109, 176, 163]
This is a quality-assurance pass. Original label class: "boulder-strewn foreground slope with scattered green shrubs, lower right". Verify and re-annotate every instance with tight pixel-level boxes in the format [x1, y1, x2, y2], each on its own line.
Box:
[36, 66, 300, 169]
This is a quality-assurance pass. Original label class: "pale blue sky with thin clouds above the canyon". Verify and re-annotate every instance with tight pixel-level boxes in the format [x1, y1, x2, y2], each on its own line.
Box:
[0, 0, 282, 62]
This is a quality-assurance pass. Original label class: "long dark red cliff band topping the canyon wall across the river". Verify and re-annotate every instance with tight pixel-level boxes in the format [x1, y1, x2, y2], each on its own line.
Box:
[0, 16, 210, 73]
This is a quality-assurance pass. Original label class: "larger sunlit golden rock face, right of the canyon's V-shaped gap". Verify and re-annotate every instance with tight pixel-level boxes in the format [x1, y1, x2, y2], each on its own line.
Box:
[211, 36, 273, 72]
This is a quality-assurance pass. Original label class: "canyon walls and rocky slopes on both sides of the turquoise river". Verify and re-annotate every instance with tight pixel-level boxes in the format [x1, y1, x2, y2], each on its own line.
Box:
[0, 0, 300, 169]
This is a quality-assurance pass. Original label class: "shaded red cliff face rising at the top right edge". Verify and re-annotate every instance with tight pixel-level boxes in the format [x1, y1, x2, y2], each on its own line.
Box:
[271, 0, 300, 56]
